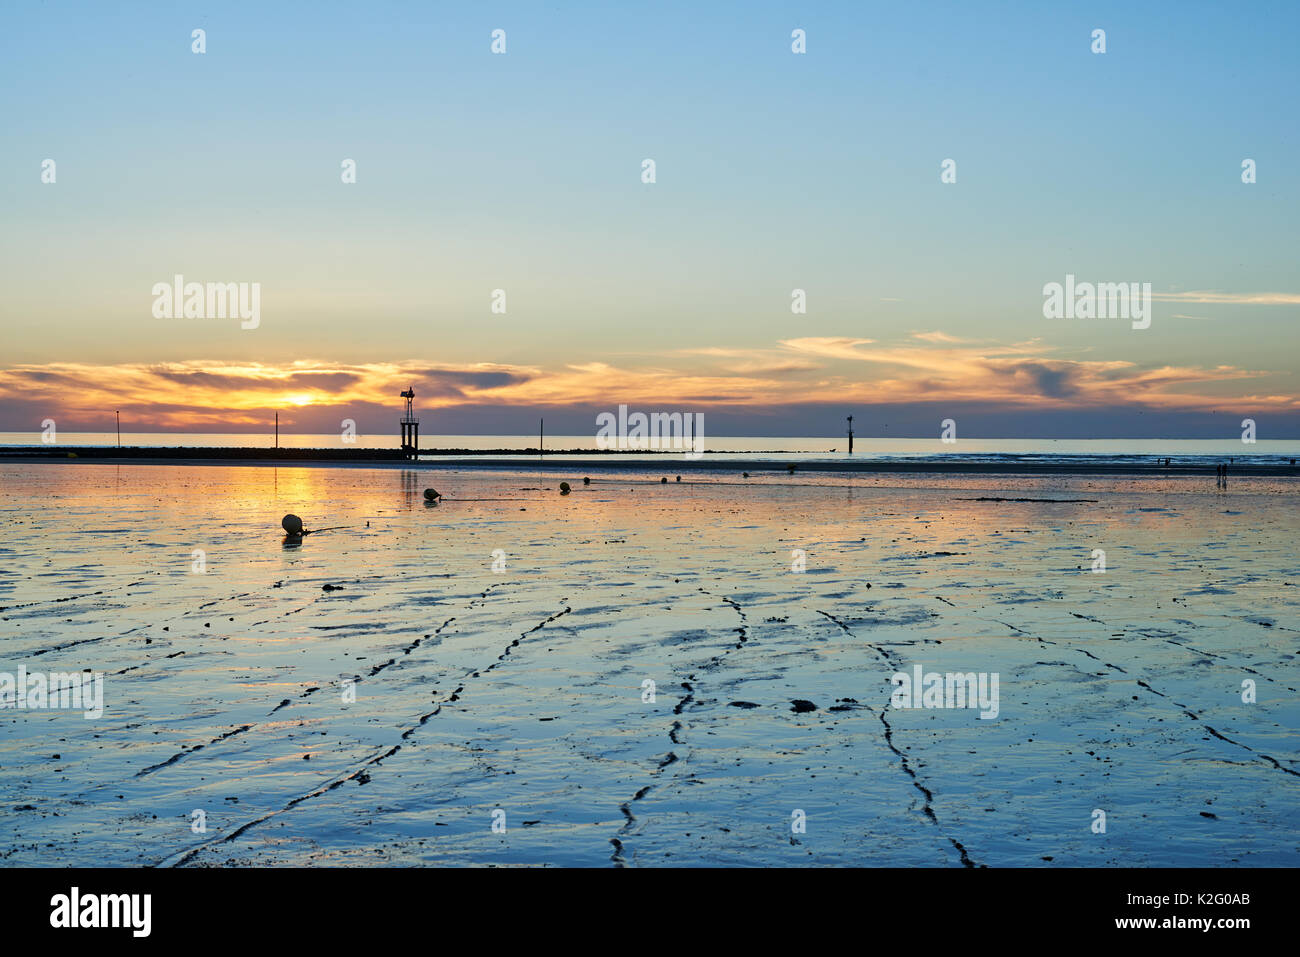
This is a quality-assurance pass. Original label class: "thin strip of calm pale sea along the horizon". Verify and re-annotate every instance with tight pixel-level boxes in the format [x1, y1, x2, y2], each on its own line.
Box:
[0, 432, 1300, 463]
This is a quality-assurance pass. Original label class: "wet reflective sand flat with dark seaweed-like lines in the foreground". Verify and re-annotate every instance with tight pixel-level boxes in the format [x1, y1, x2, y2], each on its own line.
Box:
[0, 462, 1300, 867]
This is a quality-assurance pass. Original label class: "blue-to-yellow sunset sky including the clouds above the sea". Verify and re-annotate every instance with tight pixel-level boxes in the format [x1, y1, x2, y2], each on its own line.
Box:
[0, 0, 1300, 438]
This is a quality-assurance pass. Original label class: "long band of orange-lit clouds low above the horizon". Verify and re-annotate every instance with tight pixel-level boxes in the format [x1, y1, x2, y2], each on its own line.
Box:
[0, 333, 1300, 430]
